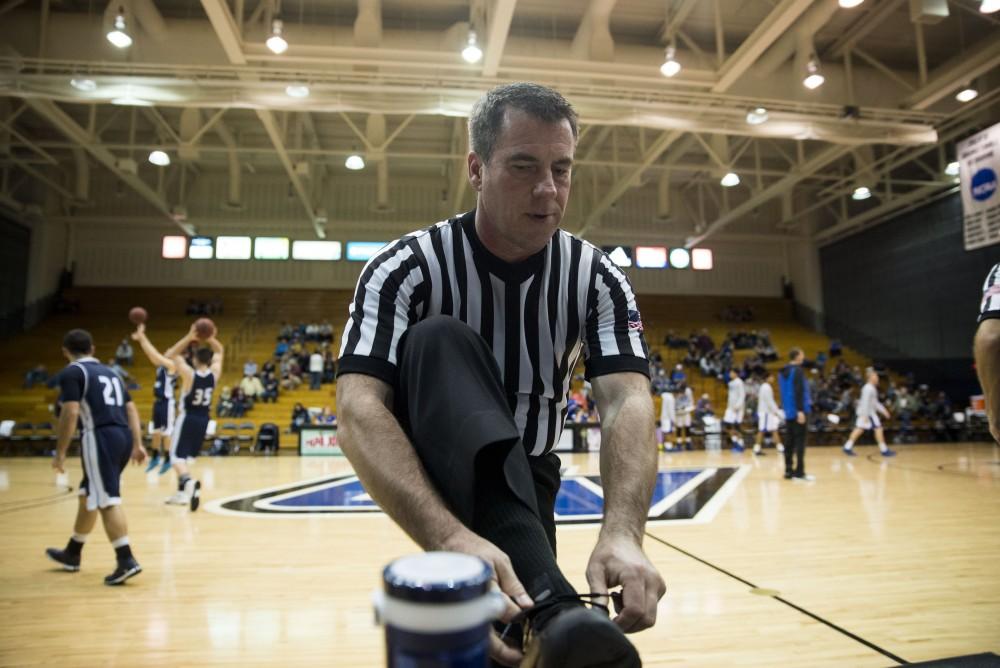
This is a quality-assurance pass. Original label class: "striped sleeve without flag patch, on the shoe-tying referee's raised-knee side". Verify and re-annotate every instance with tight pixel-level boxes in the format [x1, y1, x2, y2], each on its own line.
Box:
[337, 239, 426, 384]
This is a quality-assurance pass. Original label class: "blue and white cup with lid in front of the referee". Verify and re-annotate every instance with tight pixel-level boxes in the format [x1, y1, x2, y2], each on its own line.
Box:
[375, 552, 504, 668]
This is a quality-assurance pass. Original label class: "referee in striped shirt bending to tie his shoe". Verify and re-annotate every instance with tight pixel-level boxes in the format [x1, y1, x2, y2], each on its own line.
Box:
[337, 83, 666, 668]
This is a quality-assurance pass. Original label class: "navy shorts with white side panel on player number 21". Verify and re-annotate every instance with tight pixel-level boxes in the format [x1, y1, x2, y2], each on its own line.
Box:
[79, 426, 132, 510]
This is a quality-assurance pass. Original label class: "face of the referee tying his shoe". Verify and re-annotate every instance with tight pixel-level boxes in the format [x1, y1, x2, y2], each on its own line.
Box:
[469, 109, 576, 262]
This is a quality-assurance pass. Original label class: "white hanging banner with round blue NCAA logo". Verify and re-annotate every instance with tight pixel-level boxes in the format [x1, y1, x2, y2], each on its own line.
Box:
[958, 123, 1000, 250]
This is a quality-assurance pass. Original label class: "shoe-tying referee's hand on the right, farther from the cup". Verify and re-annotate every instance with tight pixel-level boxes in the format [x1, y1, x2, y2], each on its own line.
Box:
[587, 536, 667, 633]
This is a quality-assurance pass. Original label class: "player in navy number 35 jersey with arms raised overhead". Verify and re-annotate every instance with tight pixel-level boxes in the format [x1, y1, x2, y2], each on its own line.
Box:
[164, 325, 224, 512]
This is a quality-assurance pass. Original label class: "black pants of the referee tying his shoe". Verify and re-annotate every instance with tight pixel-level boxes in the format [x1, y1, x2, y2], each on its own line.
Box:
[393, 316, 560, 552]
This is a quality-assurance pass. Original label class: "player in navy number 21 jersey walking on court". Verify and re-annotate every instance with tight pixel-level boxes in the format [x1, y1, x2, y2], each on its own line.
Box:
[45, 329, 146, 585]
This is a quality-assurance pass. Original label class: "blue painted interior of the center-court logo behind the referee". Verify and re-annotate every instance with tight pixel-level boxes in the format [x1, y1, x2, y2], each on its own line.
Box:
[268, 469, 702, 518]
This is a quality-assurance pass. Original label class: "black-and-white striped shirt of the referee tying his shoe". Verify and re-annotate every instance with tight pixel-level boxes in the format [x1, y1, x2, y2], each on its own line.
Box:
[337, 211, 649, 455]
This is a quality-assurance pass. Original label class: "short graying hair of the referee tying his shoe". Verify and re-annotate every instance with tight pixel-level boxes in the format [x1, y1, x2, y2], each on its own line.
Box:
[469, 81, 579, 163]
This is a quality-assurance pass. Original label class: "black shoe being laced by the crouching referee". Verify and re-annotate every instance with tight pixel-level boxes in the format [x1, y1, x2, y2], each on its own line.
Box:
[501, 594, 642, 668]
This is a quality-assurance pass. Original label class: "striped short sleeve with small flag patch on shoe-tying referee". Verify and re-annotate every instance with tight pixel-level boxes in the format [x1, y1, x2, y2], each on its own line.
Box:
[583, 249, 649, 379]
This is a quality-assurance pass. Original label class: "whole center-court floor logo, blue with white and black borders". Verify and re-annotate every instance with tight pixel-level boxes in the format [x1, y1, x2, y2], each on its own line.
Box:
[205, 466, 749, 525]
